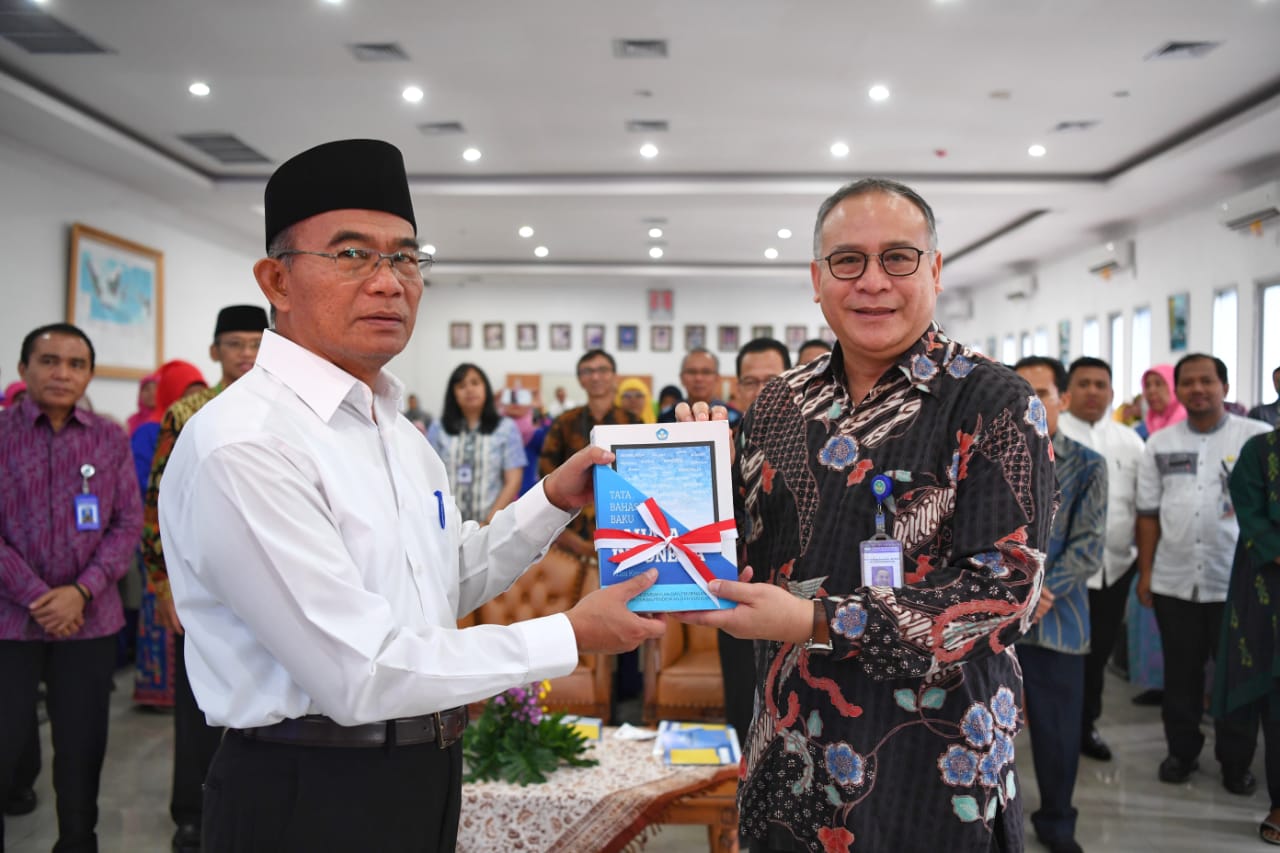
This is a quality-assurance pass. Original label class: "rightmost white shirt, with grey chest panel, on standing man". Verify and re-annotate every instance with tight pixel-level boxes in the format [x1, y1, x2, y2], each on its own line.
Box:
[1138, 414, 1271, 602]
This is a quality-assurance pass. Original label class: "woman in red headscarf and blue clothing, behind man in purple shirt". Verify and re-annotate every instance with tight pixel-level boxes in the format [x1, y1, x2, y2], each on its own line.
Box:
[129, 360, 209, 708]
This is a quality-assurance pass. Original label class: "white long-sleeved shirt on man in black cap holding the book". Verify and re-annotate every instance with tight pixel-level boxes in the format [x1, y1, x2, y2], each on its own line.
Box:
[160, 332, 579, 729]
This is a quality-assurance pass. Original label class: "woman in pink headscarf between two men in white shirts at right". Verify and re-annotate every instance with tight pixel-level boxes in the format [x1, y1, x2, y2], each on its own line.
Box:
[1126, 364, 1187, 706]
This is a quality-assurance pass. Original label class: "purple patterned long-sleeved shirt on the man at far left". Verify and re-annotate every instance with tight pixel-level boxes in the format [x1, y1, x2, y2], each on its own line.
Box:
[0, 397, 142, 642]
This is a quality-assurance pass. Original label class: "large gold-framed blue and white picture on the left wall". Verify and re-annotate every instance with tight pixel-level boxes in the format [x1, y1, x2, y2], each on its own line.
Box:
[67, 223, 164, 379]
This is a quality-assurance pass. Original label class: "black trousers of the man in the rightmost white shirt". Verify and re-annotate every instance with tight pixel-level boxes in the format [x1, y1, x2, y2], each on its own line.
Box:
[1153, 594, 1258, 776]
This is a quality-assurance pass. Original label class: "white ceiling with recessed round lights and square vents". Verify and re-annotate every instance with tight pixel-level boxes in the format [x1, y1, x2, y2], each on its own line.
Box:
[0, 0, 1280, 298]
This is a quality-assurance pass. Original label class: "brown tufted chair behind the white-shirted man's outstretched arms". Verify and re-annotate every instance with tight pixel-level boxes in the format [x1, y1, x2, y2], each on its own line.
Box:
[458, 548, 613, 722]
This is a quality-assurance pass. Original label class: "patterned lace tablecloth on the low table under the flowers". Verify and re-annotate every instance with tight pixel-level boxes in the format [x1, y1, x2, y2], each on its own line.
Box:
[458, 729, 737, 853]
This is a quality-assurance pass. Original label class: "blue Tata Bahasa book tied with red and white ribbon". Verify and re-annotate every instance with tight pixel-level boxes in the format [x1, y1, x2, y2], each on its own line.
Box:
[591, 421, 737, 612]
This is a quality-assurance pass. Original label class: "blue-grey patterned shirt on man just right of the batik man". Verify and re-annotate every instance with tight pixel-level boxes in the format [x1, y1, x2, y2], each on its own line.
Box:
[1018, 421, 1107, 654]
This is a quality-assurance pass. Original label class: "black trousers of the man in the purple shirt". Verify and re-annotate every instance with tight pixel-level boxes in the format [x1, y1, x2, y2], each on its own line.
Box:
[0, 635, 115, 853]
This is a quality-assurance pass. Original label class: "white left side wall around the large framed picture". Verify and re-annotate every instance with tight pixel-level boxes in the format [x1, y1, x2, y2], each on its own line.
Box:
[0, 137, 259, 418]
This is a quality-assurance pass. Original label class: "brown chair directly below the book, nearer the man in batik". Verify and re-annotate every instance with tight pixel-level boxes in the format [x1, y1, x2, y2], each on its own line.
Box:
[643, 620, 724, 725]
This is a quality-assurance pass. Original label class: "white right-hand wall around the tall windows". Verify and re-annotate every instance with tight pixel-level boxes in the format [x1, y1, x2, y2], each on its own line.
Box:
[943, 200, 1280, 406]
